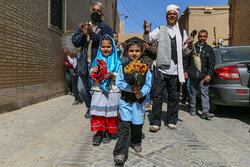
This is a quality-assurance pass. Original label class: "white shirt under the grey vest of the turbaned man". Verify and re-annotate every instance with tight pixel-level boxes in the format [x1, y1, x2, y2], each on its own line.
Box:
[143, 25, 191, 75]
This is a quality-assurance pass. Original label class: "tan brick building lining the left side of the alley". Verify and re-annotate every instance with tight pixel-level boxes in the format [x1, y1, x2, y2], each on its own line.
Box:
[0, 0, 119, 113]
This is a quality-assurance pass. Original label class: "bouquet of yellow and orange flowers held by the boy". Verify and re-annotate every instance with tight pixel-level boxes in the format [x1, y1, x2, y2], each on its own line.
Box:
[124, 60, 149, 87]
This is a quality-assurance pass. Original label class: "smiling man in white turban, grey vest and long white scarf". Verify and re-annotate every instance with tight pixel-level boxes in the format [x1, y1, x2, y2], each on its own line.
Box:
[143, 5, 193, 132]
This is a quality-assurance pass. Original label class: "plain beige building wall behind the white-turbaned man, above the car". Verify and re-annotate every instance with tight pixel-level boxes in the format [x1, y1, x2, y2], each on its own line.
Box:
[179, 6, 229, 46]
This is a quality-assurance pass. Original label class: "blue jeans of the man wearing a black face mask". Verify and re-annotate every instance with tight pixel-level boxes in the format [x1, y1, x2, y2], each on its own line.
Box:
[77, 74, 92, 109]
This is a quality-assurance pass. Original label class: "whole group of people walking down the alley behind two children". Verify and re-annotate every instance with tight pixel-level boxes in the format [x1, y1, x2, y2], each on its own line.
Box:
[64, 2, 214, 164]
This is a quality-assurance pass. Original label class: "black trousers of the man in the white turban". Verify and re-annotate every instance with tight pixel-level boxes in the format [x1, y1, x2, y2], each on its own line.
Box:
[150, 69, 180, 126]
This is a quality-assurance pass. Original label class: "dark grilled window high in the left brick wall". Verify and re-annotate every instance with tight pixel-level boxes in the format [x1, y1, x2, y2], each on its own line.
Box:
[48, 0, 66, 33]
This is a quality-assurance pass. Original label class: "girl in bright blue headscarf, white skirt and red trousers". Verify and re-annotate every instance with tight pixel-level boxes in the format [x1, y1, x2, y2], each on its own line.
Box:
[90, 35, 121, 146]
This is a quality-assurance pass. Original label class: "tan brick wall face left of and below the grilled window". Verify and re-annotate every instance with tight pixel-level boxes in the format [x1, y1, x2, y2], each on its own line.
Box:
[0, 0, 69, 110]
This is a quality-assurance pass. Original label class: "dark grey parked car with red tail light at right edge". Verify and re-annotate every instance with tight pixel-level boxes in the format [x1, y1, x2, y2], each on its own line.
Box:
[209, 46, 250, 110]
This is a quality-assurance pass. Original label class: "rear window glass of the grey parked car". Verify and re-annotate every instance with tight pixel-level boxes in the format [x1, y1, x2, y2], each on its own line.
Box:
[220, 47, 250, 62]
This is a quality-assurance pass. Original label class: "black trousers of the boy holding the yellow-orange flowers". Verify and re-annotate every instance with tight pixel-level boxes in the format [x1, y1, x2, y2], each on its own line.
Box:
[113, 120, 143, 160]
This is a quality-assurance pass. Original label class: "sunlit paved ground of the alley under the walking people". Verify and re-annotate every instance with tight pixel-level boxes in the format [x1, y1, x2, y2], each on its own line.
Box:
[0, 96, 250, 167]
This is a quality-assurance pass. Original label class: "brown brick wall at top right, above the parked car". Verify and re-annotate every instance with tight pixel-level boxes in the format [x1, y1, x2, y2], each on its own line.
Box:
[229, 0, 250, 45]
